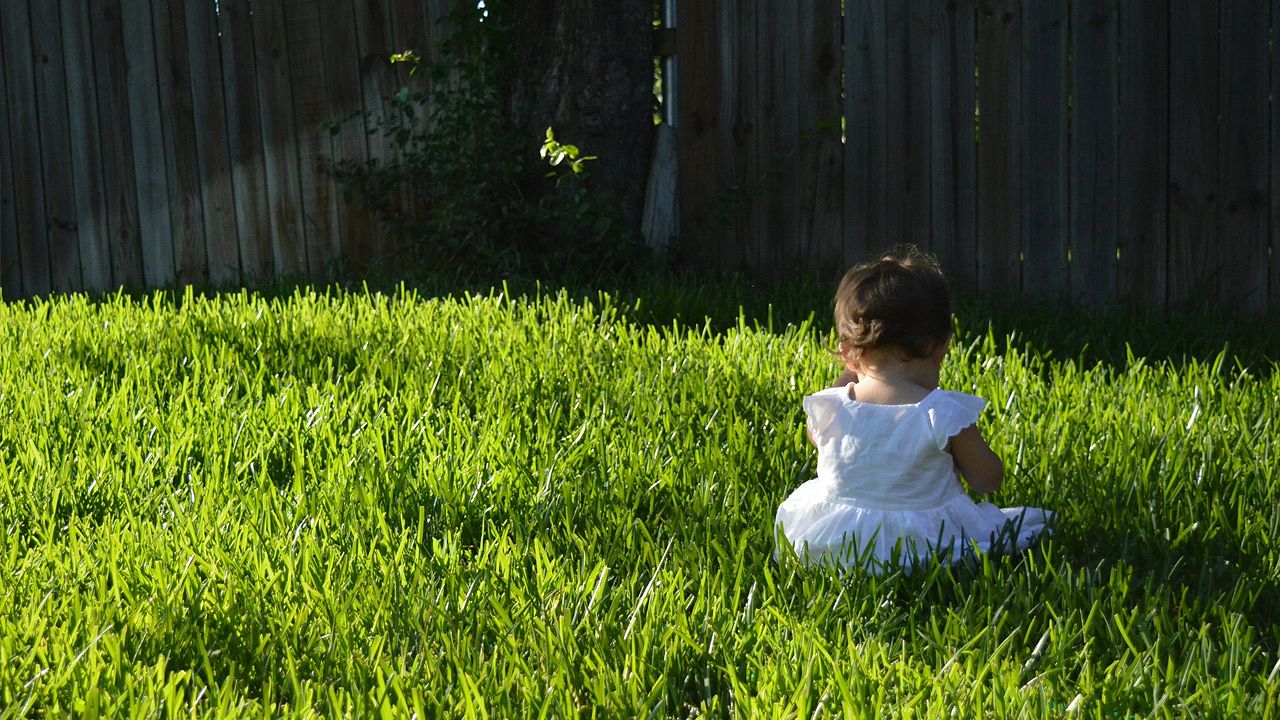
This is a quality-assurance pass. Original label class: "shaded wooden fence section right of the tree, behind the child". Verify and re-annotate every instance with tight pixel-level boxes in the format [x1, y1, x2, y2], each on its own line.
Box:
[678, 0, 1280, 311]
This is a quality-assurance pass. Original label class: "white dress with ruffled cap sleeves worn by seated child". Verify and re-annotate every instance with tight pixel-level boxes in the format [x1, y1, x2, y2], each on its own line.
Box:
[774, 387, 1053, 573]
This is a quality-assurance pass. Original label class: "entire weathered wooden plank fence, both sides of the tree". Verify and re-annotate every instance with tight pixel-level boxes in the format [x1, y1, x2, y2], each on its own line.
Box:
[0, 0, 1280, 310]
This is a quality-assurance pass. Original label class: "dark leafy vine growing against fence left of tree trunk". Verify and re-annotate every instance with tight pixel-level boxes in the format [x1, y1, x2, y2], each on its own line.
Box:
[325, 3, 643, 280]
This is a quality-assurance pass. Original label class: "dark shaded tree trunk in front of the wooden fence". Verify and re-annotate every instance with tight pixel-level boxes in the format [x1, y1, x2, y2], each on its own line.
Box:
[509, 0, 654, 231]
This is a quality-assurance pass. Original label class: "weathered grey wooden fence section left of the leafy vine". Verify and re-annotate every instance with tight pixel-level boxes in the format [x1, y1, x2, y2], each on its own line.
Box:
[0, 0, 457, 299]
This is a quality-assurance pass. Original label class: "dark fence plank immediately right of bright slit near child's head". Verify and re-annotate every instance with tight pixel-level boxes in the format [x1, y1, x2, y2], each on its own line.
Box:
[975, 0, 1023, 293]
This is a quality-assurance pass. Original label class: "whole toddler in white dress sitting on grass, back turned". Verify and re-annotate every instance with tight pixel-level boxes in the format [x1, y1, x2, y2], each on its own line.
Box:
[774, 252, 1053, 571]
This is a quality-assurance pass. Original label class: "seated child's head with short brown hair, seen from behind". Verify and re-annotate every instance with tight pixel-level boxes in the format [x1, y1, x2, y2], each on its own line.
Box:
[836, 249, 951, 363]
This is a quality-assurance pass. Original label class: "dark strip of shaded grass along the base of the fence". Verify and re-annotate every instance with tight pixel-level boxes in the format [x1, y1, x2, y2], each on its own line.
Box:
[24, 266, 1280, 375]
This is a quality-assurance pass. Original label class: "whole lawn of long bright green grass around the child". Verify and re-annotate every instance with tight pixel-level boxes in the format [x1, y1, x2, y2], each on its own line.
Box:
[0, 284, 1280, 719]
